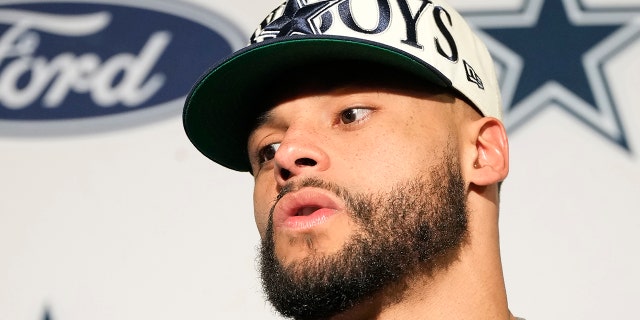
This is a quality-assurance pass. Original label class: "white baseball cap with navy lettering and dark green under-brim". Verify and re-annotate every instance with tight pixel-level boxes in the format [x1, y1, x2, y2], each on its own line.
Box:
[183, 0, 502, 171]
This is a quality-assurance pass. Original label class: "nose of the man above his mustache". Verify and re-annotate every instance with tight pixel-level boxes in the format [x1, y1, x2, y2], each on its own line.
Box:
[274, 131, 329, 187]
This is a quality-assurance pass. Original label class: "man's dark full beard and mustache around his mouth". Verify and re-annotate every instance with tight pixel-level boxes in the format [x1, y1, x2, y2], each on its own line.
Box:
[260, 154, 468, 320]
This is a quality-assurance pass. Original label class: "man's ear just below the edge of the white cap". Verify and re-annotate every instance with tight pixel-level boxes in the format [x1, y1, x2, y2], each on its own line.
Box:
[469, 117, 509, 186]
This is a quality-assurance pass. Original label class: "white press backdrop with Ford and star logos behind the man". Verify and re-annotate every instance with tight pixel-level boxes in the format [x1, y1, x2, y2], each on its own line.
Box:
[0, 0, 640, 320]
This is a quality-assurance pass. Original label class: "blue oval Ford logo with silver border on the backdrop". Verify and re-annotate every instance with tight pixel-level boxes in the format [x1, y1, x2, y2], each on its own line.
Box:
[0, 0, 245, 134]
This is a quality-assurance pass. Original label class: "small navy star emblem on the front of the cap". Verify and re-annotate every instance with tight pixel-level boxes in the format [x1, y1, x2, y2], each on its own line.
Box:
[263, 0, 344, 37]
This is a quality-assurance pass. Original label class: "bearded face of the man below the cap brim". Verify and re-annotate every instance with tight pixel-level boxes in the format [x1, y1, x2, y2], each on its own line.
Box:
[249, 87, 466, 318]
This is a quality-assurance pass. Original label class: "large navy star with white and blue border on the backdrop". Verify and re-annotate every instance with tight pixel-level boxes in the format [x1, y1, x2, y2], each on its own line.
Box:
[464, 0, 640, 150]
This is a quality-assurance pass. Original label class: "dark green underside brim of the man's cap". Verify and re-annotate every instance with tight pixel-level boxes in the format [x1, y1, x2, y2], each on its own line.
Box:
[183, 35, 451, 171]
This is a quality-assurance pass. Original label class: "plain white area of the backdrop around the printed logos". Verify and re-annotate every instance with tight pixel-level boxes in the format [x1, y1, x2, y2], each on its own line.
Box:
[0, 0, 640, 320]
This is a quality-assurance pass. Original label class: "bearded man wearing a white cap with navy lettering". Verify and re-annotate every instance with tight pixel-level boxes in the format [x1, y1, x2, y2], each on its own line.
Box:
[184, 0, 514, 319]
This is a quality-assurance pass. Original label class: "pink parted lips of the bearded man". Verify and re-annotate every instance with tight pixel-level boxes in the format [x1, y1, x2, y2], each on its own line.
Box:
[273, 187, 343, 231]
